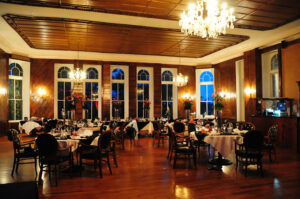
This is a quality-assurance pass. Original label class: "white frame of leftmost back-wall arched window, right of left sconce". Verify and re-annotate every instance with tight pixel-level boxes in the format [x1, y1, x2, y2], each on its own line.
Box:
[54, 63, 74, 119]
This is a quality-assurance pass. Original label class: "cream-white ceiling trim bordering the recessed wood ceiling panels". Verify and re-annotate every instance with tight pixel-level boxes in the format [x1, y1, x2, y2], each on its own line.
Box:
[0, 3, 300, 66]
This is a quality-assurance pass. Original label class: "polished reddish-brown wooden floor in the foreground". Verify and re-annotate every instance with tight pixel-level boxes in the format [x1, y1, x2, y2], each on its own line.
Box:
[0, 137, 300, 199]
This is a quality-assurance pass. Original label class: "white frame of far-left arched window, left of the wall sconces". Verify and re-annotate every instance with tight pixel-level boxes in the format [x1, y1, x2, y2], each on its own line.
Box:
[8, 58, 30, 123]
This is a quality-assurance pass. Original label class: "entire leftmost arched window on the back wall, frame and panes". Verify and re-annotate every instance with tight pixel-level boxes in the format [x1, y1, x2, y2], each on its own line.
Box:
[54, 64, 73, 119]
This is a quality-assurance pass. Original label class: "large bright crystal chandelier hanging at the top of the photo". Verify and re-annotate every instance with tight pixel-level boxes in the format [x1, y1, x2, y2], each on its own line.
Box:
[179, 0, 235, 39]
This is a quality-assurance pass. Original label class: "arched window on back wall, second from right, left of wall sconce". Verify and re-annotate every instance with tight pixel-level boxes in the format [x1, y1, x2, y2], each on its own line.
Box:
[161, 68, 177, 118]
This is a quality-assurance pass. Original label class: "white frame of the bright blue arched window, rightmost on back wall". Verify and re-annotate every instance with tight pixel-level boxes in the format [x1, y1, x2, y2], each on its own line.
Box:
[196, 68, 216, 118]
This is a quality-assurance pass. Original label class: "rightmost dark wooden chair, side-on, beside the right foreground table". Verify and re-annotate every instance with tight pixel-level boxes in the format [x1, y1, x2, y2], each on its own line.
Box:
[264, 124, 278, 162]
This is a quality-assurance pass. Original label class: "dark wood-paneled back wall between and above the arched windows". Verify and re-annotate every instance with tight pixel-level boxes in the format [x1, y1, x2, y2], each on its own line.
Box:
[30, 59, 196, 119]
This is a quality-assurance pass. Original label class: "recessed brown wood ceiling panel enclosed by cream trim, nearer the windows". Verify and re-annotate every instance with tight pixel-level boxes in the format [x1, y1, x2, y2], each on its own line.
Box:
[3, 14, 248, 58]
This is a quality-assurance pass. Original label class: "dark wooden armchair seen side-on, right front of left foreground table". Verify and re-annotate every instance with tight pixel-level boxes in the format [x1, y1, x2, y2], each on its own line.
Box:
[80, 131, 112, 178]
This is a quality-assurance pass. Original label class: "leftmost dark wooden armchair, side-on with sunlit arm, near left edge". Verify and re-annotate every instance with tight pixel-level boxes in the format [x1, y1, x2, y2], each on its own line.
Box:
[7, 129, 38, 176]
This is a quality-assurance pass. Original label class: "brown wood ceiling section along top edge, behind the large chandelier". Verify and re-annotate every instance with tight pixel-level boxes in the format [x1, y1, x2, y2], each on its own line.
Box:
[0, 0, 300, 30]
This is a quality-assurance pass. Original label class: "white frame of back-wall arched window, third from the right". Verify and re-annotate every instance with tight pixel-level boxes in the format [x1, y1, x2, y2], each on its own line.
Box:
[136, 66, 154, 119]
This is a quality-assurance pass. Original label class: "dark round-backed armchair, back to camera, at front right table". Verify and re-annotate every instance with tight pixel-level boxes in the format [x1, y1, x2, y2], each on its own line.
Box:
[235, 130, 264, 176]
